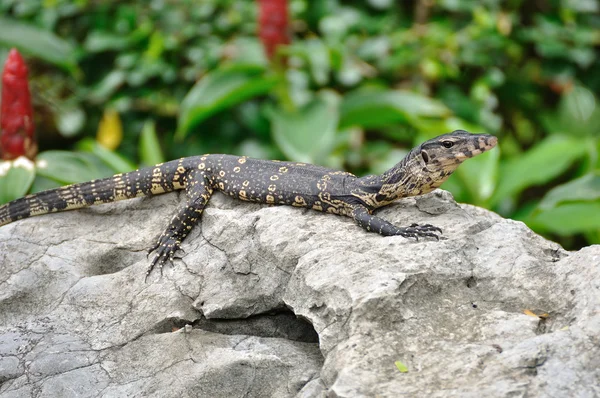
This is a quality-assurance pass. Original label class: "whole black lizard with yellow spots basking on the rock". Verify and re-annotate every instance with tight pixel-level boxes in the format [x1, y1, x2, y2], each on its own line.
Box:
[0, 130, 498, 278]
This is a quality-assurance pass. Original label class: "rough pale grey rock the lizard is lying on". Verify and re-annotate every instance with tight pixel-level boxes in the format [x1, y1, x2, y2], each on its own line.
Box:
[0, 190, 600, 398]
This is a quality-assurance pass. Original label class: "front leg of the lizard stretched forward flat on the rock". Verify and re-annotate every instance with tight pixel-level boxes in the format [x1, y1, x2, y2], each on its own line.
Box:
[351, 205, 442, 240]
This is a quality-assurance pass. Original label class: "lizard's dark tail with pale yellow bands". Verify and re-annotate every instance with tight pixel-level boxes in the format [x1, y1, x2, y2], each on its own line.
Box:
[0, 162, 183, 226]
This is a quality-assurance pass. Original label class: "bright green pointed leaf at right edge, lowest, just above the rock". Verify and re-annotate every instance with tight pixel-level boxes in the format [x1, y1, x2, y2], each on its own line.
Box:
[525, 201, 600, 236]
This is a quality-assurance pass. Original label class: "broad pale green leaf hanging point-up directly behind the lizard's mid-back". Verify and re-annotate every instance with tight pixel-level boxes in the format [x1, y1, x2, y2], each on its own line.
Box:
[268, 92, 339, 163]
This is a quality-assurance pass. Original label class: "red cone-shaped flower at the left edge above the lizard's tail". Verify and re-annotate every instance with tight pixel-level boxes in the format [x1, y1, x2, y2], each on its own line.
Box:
[0, 48, 37, 160]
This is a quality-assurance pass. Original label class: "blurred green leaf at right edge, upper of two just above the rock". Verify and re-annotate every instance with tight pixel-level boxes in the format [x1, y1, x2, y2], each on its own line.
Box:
[539, 170, 600, 210]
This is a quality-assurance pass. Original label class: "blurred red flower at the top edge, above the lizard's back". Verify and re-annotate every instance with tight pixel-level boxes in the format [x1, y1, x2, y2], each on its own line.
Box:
[258, 0, 290, 59]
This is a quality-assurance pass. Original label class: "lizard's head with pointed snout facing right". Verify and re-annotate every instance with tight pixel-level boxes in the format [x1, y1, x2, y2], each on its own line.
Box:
[417, 130, 498, 175]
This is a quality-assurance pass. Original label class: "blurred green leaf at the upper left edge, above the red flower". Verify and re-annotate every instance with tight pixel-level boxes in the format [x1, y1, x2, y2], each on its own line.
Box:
[0, 17, 78, 74]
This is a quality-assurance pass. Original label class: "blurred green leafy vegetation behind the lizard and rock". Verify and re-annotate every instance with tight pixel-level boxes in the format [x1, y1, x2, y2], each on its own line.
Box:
[0, 0, 600, 249]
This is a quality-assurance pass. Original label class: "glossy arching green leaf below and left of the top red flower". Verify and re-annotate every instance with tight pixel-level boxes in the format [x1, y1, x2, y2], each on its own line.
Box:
[176, 65, 277, 139]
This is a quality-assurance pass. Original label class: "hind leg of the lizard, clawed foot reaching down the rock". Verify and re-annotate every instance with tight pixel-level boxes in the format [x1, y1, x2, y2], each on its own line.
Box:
[146, 172, 213, 280]
